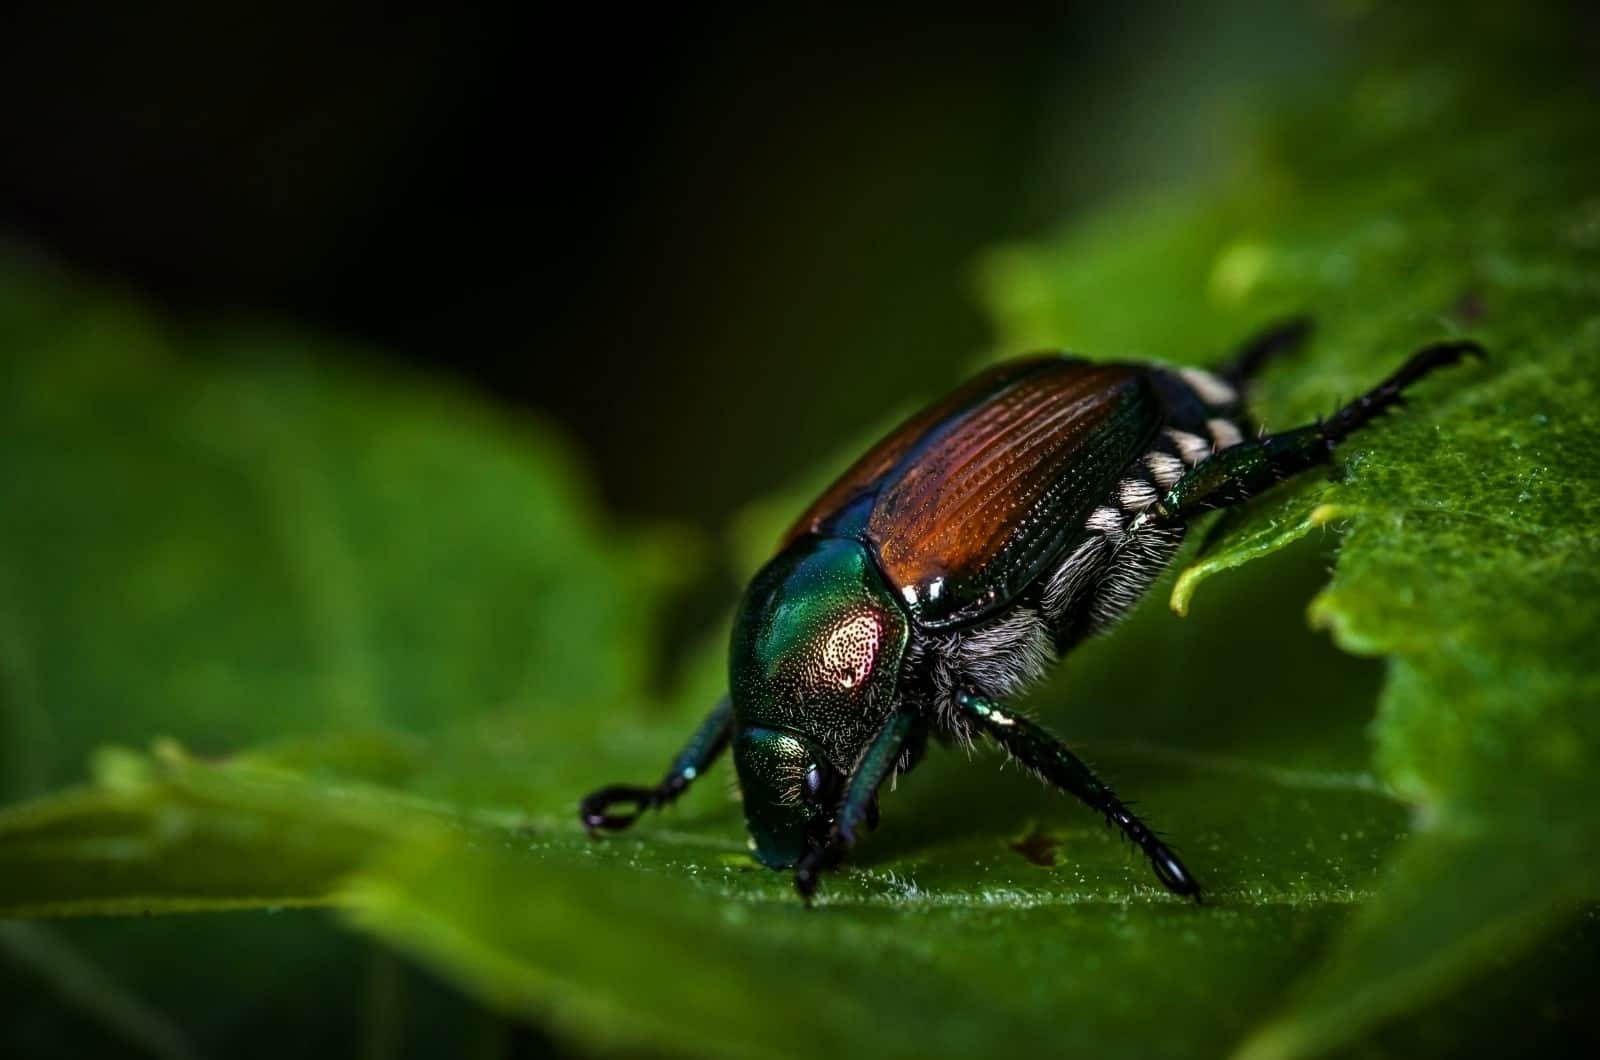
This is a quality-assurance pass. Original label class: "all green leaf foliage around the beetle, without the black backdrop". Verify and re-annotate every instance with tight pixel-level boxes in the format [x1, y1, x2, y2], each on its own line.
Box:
[0, 4, 1600, 1057]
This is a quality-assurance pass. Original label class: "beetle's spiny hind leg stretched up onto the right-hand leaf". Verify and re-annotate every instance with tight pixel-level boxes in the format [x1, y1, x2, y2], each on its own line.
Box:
[1128, 341, 1483, 535]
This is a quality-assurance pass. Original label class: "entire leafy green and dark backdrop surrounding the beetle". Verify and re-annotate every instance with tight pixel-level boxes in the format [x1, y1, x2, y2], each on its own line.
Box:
[0, 2, 1600, 1057]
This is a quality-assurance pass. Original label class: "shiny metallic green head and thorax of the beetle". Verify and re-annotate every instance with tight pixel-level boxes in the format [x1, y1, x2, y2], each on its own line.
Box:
[728, 536, 907, 868]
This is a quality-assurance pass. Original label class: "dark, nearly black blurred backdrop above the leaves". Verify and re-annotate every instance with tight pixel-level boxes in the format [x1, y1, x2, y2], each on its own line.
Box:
[0, 2, 1331, 525]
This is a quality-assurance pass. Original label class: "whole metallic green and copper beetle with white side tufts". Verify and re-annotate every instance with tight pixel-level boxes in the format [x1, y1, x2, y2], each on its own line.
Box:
[579, 317, 1483, 901]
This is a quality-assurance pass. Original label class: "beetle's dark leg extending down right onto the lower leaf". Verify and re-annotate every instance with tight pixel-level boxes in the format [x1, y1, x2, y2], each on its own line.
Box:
[955, 692, 1200, 901]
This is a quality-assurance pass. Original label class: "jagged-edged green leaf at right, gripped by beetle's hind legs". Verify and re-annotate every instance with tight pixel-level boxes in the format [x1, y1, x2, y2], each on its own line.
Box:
[987, 8, 1600, 1057]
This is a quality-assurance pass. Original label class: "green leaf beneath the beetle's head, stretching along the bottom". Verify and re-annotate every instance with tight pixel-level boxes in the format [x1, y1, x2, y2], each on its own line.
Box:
[0, 656, 1402, 1055]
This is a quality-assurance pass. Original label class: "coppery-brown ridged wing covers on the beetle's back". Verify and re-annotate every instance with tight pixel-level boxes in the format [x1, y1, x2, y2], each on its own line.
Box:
[786, 355, 1163, 628]
